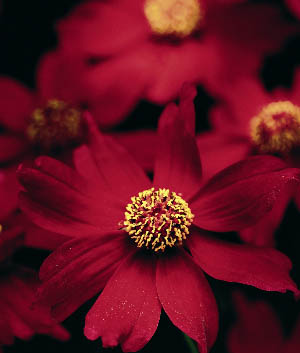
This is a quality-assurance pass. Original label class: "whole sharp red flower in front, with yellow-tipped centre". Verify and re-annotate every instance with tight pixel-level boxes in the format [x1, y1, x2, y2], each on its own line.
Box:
[18, 86, 299, 352]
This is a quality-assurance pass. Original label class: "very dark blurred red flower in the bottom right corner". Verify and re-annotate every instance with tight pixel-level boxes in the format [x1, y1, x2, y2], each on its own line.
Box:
[227, 293, 300, 353]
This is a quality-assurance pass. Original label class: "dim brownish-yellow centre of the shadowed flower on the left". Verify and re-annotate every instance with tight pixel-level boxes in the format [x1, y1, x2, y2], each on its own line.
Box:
[27, 99, 82, 152]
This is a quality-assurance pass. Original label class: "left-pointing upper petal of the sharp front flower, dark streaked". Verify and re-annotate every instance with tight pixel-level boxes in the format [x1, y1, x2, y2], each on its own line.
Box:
[18, 158, 123, 236]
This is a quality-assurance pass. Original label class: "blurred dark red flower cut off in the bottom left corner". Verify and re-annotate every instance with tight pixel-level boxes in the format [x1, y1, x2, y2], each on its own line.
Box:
[0, 226, 69, 352]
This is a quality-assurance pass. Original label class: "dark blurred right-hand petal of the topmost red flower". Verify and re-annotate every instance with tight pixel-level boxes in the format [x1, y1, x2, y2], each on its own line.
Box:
[207, 2, 297, 88]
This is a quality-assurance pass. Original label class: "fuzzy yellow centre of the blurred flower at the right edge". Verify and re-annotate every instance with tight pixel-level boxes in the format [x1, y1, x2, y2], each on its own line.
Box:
[250, 101, 300, 154]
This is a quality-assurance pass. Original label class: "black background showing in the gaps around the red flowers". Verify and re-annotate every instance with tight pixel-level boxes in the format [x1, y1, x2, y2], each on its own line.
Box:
[0, 0, 300, 353]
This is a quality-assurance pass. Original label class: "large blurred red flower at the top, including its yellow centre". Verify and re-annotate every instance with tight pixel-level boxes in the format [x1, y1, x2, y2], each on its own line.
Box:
[43, 0, 294, 126]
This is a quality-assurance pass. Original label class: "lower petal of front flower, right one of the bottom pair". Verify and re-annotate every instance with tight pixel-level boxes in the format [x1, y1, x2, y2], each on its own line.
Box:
[156, 252, 218, 353]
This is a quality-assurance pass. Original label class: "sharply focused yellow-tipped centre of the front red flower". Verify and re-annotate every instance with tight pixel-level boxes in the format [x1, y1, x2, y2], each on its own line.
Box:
[124, 188, 194, 252]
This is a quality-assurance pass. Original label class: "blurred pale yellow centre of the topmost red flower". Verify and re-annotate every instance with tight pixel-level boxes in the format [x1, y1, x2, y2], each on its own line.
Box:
[144, 0, 204, 37]
